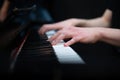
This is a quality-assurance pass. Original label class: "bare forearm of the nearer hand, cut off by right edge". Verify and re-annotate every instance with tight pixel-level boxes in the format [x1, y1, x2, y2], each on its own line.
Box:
[100, 28, 120, 46]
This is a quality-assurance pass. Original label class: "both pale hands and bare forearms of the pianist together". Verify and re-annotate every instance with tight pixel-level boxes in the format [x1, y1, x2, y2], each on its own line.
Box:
[38, 9, 120, 46]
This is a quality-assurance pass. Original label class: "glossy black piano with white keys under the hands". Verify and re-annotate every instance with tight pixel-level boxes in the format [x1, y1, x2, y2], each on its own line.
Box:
[0, 3, 120, 80]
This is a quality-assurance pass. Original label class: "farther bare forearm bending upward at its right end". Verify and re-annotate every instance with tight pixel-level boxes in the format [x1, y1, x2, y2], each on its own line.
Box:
[70, 9, 112, 27]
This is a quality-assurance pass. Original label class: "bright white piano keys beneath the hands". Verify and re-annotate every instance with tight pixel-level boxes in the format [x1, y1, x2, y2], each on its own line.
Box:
[46, 30, 85, 64]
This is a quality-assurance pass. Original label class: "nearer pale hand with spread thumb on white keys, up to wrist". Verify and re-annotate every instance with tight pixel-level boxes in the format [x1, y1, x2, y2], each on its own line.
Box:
[48, 27, 101, 46]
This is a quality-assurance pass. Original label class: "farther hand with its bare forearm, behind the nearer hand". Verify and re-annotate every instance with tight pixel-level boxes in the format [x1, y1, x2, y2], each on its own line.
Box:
[38, 10, 111, 34]
